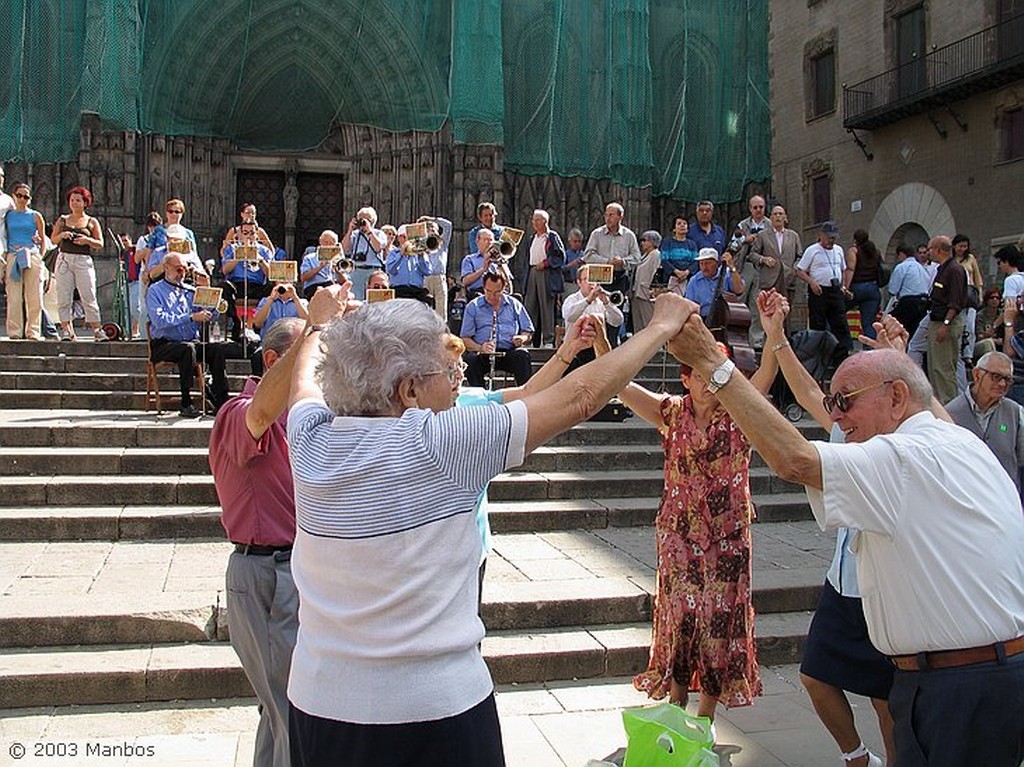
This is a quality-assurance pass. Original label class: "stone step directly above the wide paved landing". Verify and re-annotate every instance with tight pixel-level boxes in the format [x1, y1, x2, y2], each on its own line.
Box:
[0, 493, 812, 542]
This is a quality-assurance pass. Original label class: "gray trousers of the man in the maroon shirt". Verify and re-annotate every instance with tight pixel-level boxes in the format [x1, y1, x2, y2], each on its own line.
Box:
[226, 552, 299, 767]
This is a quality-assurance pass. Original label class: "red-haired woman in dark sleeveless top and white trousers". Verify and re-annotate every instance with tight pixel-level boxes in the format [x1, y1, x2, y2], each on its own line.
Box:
[51, 186, 106, 341]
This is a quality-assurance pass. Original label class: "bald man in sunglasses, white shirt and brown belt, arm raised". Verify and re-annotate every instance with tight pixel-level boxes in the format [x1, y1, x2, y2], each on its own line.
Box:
[669, 317, 1024, 767]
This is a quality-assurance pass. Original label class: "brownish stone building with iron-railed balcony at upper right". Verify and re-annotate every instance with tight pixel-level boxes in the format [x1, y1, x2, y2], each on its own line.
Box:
[770, 0, 1024, 275]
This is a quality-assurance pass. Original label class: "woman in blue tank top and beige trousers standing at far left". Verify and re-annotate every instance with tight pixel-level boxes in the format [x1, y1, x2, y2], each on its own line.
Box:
[0, 183, 46, 341]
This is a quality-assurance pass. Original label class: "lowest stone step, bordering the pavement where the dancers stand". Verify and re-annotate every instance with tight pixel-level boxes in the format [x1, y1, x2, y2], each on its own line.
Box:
[0, 612, 810, 709]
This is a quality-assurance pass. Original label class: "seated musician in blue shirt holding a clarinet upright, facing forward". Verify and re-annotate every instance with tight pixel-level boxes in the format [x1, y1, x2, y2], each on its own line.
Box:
[460, 271, 534, 386]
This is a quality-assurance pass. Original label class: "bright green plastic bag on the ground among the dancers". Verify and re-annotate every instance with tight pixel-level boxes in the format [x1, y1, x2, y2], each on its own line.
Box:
[623, 704, 719, 767]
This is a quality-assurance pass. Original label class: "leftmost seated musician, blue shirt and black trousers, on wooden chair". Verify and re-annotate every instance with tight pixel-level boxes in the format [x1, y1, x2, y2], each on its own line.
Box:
[145, 253, 227, 418]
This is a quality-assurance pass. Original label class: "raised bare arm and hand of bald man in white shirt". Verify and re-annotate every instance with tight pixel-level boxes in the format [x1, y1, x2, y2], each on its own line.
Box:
[671, 316, 822, 489]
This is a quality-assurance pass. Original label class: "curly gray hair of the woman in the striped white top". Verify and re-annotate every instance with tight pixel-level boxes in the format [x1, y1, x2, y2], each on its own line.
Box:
[315, 298, 447, 416]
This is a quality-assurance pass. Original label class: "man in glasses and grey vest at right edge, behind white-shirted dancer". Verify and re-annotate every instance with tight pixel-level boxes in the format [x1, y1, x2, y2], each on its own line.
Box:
[946, 351, 1024, 496]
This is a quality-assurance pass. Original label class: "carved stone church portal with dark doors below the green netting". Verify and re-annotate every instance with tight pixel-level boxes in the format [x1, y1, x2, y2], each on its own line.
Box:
[4, 116, 764, 313]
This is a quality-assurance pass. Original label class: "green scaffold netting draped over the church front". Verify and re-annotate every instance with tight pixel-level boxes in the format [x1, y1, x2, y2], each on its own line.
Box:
[0, 0, 770, 201]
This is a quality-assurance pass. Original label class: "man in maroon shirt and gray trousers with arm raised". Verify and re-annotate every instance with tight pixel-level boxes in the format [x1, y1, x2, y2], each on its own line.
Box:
[210, 317, 305, 767]
